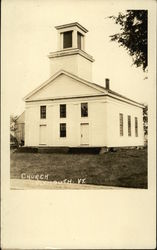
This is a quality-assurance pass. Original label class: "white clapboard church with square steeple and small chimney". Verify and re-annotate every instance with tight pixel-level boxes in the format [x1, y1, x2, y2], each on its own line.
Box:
[24, 22, 144, 148]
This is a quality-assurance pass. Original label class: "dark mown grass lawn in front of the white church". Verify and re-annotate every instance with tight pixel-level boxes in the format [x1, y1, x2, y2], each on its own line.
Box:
[10, 149, 147, 188]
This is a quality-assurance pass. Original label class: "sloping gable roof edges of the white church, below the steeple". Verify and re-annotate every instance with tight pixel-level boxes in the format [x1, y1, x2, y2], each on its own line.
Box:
[23, 70, 144, 108]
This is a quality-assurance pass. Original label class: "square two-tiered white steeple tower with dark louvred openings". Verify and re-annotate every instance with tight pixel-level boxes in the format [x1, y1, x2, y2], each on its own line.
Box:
[49, 22, 94, 81]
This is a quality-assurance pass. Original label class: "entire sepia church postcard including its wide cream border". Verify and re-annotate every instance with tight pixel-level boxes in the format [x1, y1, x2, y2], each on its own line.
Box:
[2, 0, 156, 249]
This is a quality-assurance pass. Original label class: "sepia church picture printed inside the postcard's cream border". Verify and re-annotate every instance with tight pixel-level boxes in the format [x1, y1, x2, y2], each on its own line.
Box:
[10, 1, 148, 189]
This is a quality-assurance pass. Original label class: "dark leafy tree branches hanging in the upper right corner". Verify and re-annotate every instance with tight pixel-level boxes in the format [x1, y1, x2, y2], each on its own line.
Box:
[109, 10, 148, 71]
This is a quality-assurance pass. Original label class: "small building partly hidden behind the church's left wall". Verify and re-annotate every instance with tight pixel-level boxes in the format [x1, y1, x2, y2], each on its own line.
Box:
[14, 111, 25, 143]
